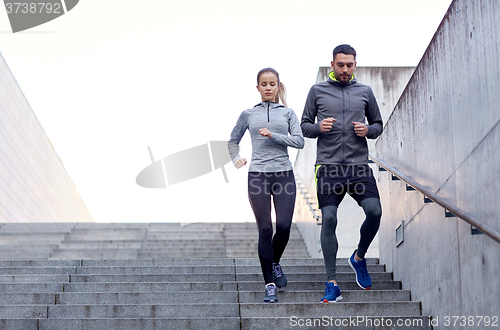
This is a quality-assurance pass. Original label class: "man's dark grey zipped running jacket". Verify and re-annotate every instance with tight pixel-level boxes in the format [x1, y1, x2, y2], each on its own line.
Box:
[300, 75, 382, 165]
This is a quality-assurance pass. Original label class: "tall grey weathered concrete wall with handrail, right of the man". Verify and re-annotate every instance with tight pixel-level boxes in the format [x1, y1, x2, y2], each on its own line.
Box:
[376, 0, 500, 329]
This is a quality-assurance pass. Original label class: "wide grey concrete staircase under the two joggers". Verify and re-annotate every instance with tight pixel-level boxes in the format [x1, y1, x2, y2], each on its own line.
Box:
[0, 223, 431, 330]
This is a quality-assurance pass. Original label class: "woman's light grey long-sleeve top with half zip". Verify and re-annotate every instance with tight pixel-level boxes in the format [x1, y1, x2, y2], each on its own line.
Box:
[228, 102, 304, 172]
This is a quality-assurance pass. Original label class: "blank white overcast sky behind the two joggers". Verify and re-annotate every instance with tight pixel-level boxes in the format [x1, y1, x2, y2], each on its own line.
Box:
[0, 0, 451, 222]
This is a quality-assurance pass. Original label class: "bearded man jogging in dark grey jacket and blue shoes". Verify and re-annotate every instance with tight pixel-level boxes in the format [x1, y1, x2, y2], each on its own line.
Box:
[301, 45, 382, 303]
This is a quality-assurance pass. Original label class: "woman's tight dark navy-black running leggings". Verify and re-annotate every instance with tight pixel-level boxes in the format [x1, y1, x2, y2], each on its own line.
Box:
[248, 170, 297, 284]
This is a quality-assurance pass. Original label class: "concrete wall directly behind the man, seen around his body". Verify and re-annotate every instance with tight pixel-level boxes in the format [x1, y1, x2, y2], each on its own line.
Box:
[295, 67, 415, 258]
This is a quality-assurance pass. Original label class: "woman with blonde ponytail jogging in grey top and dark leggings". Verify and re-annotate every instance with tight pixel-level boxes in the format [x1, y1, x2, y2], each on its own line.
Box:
[228, 68, 304, 303]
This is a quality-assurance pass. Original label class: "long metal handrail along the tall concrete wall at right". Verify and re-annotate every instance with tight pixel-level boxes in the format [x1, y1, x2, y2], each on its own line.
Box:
[369, 154, 500, 243]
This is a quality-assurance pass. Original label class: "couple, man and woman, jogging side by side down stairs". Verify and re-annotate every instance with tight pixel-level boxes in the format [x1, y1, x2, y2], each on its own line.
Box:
[228, 45, 382, 303]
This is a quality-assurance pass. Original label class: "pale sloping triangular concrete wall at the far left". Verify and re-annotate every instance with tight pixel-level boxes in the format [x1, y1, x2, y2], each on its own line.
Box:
[0, 55, 93, 222]
